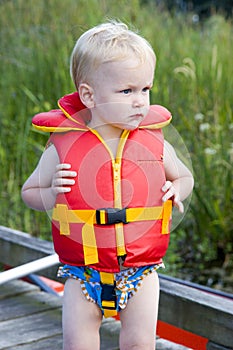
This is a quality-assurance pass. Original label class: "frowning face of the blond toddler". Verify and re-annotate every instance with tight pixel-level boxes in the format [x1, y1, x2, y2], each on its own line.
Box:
[87, 58, 154, 133]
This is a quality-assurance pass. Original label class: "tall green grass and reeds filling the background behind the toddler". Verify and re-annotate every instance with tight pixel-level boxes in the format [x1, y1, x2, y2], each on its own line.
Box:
[0, 0, 233, 290]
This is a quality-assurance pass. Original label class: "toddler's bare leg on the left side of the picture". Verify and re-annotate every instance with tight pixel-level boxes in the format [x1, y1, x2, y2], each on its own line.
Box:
[62, 279, 102, 350]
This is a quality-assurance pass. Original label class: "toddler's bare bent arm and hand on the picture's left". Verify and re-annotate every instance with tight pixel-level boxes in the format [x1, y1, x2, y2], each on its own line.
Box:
[22, 145, 77, 211]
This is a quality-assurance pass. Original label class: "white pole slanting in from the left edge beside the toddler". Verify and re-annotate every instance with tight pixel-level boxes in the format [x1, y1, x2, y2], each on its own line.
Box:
[0, 254, 59, 285]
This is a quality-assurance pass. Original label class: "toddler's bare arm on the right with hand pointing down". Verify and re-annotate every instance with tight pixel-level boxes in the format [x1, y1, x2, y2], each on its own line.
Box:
[162, 141, 194, 213]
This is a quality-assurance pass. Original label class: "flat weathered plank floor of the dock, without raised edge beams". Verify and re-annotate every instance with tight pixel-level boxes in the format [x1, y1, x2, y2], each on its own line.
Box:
[0, 280, 191, 350]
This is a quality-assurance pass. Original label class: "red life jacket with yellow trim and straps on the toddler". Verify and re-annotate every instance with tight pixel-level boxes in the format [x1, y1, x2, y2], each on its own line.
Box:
[33, 93, 172, 272]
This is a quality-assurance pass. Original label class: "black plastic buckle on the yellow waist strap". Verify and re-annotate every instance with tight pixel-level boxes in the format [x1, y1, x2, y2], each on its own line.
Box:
[96, 208, 128, 225]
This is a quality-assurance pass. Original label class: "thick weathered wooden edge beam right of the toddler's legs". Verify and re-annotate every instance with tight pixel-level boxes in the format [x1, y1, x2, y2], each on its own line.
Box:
[159, 280, 233, 348]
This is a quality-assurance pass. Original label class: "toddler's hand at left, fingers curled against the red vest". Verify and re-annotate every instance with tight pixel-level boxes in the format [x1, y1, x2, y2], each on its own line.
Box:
[51, 163, 77, 196]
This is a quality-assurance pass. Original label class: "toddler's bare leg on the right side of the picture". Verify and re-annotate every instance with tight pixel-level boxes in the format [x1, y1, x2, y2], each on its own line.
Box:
[120, 272, 159, 350]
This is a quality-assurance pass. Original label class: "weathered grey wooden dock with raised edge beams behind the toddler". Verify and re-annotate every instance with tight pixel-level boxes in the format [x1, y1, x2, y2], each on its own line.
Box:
[0, 226, 233, 350]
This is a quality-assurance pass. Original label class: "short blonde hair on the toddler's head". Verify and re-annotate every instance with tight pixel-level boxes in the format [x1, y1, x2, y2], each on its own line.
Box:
[70, 21, 156, 89]
